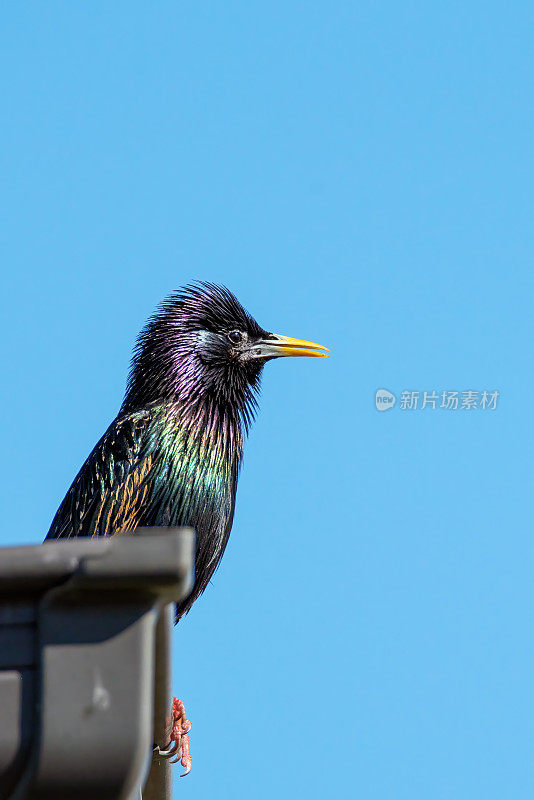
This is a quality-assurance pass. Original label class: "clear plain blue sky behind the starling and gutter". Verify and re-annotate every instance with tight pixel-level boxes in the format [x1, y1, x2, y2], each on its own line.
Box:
[0, 0, 534, 800]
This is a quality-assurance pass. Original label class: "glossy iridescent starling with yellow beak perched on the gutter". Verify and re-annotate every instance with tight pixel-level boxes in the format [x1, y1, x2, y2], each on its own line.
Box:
[46, 282, 328, 774]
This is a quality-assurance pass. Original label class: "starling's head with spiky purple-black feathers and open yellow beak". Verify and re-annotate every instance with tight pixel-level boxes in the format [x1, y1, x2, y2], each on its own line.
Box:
[123, 283, 327, 426]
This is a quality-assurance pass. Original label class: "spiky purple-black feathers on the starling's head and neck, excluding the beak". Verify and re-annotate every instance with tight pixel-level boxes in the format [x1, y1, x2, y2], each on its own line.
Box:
[121, 284, 266, 446]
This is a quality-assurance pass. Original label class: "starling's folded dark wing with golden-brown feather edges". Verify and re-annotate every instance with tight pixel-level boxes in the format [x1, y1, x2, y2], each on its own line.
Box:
[46, 410, 156, 539]
